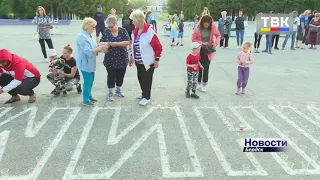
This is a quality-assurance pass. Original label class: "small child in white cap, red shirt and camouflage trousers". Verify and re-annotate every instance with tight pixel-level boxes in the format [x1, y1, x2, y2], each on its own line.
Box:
[186, 42, 203, 99]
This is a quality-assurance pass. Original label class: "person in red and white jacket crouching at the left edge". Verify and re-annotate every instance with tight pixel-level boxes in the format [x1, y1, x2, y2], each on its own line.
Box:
[0, 49, 41, 104]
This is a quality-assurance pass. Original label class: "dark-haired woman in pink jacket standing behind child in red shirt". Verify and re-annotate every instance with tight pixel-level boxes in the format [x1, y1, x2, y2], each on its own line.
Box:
[192, 15, 221, 92]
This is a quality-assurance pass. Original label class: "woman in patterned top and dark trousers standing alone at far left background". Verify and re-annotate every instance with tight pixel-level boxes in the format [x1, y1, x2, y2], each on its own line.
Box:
[32, 6, 54, 62]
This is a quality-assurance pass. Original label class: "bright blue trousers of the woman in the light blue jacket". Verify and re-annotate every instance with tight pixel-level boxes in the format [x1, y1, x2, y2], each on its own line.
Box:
[81, 71, 94, 103]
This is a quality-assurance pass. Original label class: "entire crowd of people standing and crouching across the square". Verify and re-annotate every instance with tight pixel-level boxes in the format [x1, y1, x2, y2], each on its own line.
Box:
[0, 5, 320, 106]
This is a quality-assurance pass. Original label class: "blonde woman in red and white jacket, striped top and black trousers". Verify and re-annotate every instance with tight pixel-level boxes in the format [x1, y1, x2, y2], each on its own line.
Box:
[129, 10, 162, 105]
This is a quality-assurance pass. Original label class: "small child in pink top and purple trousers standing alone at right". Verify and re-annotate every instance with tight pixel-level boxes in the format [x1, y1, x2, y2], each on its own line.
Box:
[236, 42, 254, 95]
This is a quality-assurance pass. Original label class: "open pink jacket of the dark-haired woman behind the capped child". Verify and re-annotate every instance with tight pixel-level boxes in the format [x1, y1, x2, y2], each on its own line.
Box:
[192, 24, 221, 61]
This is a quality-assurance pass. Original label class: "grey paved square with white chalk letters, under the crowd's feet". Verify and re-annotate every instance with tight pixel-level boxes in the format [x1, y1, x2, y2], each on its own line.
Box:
[0, 22, 320, 180]
